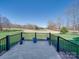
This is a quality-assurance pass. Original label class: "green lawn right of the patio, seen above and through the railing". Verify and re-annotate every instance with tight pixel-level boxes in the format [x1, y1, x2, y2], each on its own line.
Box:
[52, 33, 79, 54]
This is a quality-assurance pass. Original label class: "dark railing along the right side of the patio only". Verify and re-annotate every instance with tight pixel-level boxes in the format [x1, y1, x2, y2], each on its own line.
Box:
[51, 34, 79, 59]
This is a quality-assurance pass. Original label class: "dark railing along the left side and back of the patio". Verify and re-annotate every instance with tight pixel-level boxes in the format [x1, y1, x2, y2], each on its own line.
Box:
[0, 32, 49, 55]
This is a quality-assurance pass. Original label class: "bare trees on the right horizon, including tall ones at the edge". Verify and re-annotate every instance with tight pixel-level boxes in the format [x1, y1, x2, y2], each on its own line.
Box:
[48, 0, 79, 32]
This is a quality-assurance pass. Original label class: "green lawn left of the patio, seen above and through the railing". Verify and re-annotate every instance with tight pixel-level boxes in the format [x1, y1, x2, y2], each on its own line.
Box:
[0, 31, 21, 52]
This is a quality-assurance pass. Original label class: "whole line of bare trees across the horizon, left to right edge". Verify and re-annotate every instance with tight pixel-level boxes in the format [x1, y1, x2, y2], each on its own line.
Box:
[0, 0, 79, 32]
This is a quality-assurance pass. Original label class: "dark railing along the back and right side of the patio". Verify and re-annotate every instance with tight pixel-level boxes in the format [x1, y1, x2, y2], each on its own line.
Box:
[23, 33, 79, 59]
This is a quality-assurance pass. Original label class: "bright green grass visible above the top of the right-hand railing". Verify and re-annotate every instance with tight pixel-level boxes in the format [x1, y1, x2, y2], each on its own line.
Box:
[55, 33, 79, 45]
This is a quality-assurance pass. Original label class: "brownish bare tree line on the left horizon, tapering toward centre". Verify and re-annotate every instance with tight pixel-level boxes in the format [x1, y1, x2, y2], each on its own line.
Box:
[0, 16, 44, 31]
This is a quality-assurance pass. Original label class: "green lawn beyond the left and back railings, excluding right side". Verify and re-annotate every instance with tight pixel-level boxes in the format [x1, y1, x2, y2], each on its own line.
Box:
[0, 31, 49, 52]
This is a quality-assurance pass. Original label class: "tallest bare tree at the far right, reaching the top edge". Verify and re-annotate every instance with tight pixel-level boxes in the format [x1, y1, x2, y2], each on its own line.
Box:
[67, 0, 79, 32]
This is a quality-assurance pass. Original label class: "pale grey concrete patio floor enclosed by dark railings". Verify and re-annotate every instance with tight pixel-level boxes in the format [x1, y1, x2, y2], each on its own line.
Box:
[0, 41, 61, 59]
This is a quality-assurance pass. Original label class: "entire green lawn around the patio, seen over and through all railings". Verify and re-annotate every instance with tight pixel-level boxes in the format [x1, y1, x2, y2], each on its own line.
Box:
[0, 31, 79, 56]
